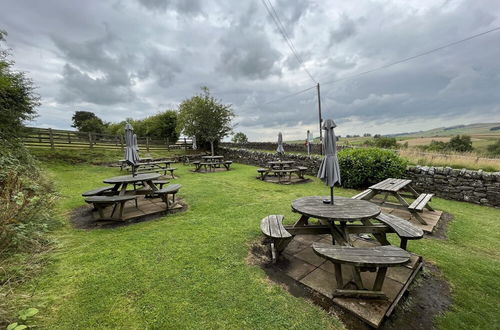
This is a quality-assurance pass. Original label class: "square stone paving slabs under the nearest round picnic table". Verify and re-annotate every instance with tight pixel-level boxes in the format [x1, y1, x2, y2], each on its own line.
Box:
[277, 235, 422, 328]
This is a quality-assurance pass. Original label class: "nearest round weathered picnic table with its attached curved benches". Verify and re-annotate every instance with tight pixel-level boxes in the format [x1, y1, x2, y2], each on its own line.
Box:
[261, 196, 423, 299]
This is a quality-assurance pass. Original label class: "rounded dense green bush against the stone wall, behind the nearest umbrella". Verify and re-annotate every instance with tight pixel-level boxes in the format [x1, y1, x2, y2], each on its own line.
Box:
[338, 148, 407, 188]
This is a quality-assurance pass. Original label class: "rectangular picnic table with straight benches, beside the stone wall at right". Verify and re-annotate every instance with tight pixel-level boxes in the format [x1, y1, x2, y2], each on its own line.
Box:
[354, 178, 434, 225]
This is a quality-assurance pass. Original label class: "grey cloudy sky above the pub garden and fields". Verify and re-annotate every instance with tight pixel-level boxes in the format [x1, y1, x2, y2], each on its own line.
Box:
[0, 0, 500, 140]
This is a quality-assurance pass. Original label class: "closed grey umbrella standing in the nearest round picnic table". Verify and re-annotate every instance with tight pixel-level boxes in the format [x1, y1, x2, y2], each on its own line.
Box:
[317, 119, 340, 204]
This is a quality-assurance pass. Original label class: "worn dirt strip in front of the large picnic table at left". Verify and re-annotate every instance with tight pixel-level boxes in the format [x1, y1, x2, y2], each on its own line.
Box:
[70, 199, 187, 229]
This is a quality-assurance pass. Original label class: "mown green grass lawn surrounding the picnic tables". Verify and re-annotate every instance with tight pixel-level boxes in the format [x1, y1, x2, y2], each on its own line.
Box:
[14, 163, 500, 329]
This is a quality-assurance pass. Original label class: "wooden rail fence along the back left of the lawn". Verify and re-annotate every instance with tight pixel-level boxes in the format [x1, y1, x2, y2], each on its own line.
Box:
[22, 127, 192, 152]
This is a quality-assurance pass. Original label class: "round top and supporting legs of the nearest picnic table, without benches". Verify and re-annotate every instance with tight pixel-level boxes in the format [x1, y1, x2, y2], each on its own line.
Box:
[292, 196, 381, 245]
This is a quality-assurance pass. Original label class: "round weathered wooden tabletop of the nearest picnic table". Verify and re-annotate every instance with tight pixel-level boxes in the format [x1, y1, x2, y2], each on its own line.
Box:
[292, 196, 380, 221]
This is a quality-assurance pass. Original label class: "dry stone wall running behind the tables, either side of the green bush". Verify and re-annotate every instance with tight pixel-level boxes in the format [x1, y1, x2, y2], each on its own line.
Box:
[219, 147, 500, 207]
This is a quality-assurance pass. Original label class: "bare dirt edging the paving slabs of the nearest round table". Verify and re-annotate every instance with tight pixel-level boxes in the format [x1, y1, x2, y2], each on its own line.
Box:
[247, 239, 451, 330]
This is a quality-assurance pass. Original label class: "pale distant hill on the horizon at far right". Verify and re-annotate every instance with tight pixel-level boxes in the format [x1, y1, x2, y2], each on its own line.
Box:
[387, 123, 500, 138]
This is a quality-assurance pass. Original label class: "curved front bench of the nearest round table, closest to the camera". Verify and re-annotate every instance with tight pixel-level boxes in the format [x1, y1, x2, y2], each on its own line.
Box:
[313, 242, 410, 299]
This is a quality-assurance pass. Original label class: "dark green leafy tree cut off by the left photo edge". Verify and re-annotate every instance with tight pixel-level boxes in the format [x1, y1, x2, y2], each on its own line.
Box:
[0, 30, 40, 139]
